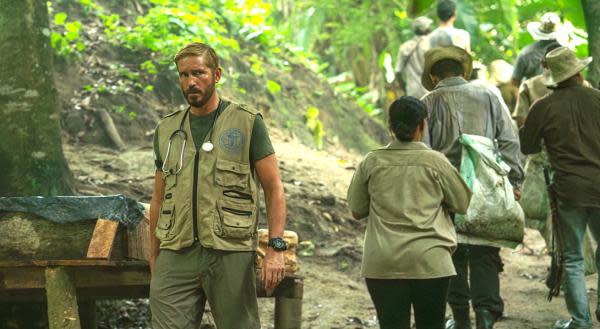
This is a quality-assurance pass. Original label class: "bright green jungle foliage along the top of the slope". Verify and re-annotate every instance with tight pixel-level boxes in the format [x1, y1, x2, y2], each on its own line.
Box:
[51, 0, 587, 115]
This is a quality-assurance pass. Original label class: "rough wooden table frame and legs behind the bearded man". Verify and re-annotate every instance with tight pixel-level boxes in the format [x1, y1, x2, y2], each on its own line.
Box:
[0, 259, 304, 329]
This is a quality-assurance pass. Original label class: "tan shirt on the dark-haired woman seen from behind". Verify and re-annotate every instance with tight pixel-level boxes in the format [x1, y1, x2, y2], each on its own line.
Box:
[348, 141, 471, 279]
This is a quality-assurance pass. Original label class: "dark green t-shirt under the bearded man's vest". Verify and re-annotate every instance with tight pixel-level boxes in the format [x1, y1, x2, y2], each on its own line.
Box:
[153, 100, 275, 170]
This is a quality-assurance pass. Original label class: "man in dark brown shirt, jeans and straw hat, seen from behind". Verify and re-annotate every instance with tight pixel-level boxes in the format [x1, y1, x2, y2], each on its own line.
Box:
[520, 47, 600, 329]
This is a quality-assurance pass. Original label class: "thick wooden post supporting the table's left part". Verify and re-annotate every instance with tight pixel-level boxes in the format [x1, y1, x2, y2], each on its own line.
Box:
[46, 267, 81, 329]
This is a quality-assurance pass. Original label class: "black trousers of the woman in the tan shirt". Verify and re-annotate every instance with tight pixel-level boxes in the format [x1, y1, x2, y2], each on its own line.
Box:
[366, 277, 450, 329]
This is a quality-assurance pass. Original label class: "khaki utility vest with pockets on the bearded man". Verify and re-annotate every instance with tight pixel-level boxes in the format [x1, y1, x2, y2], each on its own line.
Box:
[155, 103, 260, 251]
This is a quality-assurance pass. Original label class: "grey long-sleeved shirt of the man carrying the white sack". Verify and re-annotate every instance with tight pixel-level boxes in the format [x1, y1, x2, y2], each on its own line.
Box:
[422, 77, 524, 185]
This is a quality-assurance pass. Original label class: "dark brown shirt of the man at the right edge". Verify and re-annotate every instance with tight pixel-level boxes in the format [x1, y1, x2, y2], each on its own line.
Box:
[520, 82, 600, 207]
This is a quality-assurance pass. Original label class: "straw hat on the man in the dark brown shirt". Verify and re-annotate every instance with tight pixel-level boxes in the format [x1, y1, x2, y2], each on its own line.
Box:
[544, 47, 592, 86]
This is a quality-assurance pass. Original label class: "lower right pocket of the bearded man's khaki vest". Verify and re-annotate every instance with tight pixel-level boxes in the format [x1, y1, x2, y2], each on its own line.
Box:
[214, 200, 257, 239]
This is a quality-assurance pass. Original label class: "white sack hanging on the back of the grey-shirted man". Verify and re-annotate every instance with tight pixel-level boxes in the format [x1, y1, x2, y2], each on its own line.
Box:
[455, 134, 525, 246]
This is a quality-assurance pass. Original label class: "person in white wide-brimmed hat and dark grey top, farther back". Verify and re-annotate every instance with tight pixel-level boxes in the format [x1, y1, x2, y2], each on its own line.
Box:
[512, 13, 561, 88]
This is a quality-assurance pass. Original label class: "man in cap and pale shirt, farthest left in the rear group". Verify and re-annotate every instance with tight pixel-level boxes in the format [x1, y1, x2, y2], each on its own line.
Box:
[396, 16, 433, 98]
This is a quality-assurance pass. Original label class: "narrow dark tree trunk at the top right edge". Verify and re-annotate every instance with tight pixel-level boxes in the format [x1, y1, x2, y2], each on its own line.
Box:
[581, 0, 600, 88]
